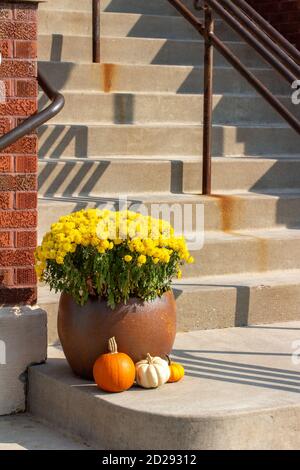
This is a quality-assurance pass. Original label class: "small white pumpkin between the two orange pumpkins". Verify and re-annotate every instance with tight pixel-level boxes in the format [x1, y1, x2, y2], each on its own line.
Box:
[135, 354, 170, 388]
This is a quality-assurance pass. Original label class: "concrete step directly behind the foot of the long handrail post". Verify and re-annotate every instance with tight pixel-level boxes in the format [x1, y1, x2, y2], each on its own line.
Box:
[39, 157, 300, 198]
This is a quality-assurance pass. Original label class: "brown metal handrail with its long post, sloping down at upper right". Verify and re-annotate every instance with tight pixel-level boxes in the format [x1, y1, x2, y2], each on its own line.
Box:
[168, 0, 300, 194]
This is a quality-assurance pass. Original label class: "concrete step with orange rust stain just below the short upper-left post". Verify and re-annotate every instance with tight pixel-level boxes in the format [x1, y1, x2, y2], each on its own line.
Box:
[39, 62, 290, 97]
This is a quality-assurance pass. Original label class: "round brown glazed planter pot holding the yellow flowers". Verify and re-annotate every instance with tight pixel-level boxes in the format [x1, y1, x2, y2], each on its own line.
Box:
[58, 291, 176, 379]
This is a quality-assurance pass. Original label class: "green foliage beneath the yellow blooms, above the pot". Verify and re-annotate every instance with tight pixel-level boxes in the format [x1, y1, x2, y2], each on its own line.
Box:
[43, 245, 180, 309]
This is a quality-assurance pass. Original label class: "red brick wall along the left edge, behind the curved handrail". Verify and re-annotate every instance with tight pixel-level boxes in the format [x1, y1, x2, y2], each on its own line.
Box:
[0, 0, 37, 304]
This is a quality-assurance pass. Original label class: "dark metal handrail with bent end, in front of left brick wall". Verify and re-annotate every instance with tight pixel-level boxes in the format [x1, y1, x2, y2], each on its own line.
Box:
[0, 71, 65, 150]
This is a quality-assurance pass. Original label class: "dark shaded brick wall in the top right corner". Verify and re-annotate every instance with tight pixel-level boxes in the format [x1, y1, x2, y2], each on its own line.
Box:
[249, 0, 300, 49]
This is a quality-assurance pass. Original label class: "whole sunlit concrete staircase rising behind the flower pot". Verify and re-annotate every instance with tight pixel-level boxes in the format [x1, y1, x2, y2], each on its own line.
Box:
[30, 0, 300, 448]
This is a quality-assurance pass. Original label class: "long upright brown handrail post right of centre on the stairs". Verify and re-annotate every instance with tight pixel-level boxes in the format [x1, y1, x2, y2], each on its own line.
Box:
[202, 4, 214, 195]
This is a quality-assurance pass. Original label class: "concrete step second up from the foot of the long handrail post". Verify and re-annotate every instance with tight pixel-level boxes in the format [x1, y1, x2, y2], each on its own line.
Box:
[38, 120, 299, 158]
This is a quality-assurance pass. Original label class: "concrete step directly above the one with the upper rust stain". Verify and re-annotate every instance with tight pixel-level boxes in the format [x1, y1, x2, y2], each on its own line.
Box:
[39, 35, 264, 67]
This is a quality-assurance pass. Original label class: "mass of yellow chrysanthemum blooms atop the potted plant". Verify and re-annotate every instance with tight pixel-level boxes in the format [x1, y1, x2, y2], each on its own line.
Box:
[35, 209, 194, 278]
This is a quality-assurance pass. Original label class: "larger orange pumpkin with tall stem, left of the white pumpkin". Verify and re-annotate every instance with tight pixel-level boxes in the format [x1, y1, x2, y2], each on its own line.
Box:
[93, 337, 135, 392]
